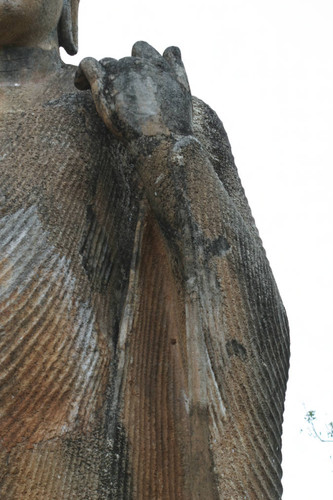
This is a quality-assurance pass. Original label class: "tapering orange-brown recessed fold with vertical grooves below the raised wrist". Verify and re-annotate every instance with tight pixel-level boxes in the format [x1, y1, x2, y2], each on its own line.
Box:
[123, 216, 189, 500]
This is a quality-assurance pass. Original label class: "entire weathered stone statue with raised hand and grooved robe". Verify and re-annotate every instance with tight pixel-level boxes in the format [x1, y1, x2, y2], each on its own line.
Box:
[0, 0, 289, 500]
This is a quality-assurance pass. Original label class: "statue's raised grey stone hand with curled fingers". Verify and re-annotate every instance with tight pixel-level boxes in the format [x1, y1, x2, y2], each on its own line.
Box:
[75, 42, 192, 142]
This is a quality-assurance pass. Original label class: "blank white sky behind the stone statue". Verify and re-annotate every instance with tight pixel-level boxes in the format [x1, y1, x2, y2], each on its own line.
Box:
[61, 0, 333, 500]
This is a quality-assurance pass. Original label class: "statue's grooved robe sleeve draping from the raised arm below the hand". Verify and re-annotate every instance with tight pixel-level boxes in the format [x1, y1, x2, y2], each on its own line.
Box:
[111, 96, 289, 499]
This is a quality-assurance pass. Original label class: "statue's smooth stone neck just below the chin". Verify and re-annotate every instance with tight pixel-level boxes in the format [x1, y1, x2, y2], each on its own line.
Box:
[0, 47, 62, 86]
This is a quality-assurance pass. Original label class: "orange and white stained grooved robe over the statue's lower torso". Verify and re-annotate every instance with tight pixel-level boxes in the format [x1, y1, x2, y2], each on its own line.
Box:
[0, 207, 109, 500]
